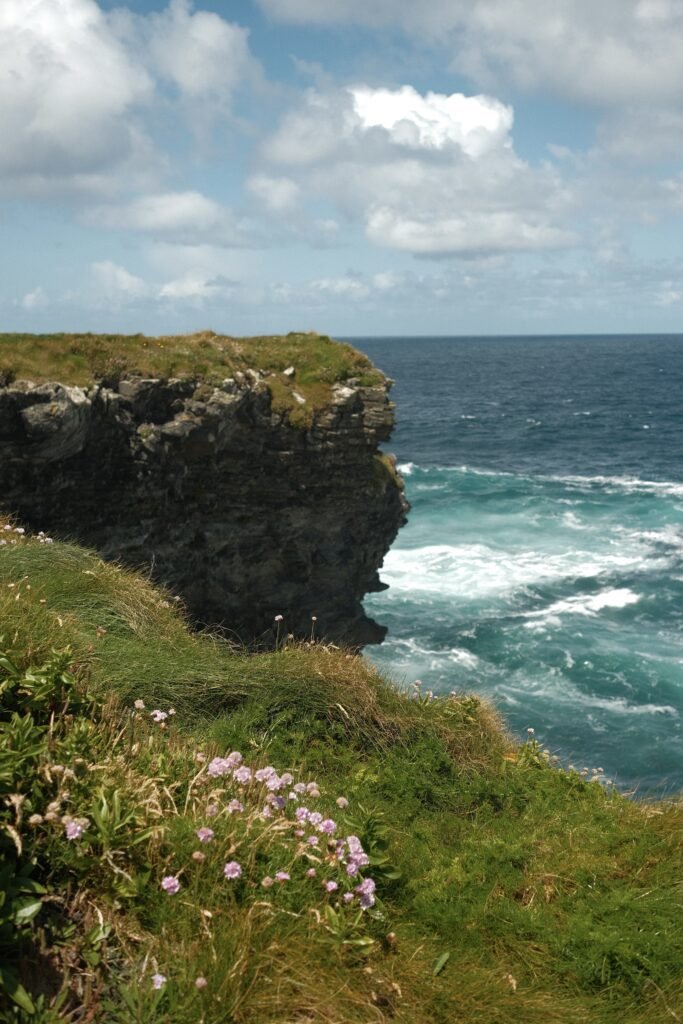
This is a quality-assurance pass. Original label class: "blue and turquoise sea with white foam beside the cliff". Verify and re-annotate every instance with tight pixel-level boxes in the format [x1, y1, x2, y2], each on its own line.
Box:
[350, 335, 683, 796]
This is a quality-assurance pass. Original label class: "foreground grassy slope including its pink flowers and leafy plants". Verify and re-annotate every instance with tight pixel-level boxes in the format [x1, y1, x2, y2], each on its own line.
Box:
[0, 519, 683, 1024]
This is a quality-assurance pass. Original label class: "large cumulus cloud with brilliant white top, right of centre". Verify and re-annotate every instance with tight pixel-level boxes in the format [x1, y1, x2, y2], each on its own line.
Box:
[263, 85, 575, 256]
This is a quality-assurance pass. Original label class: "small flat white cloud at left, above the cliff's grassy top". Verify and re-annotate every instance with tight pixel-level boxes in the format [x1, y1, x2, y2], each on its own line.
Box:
[85, 191, 239, 245]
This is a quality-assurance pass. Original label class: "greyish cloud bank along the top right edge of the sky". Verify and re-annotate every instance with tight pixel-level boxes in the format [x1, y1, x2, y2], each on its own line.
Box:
[258, 0, 683, 106]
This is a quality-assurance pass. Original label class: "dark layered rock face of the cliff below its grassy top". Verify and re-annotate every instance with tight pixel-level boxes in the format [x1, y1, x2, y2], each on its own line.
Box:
[0, 371, 408, 645]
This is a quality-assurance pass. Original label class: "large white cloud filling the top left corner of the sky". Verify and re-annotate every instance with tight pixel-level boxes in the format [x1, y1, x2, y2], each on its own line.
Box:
[0, 0, 152, 183]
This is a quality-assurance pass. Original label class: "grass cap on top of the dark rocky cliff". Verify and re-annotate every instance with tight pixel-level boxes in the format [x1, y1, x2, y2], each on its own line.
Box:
[0, 331, 384, 426]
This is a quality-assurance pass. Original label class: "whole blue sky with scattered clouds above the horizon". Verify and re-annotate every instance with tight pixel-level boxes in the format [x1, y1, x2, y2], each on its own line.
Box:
[0, 0, 683, 337]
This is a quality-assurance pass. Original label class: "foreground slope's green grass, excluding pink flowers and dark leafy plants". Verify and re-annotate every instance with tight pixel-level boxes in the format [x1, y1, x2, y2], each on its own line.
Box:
[0, 534, 683, 1024]
